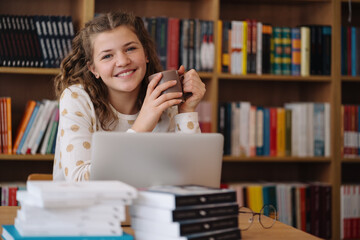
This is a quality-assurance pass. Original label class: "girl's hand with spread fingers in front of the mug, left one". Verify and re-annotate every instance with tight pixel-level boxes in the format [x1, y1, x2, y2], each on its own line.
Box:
[132, 73, 182, 132]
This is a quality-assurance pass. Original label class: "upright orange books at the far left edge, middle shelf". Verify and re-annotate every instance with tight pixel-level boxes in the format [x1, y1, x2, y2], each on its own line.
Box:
[0, 97, 12, 154]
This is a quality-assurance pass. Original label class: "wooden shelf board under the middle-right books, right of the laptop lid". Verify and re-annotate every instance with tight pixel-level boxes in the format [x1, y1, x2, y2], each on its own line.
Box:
[223, 156, 331, 163]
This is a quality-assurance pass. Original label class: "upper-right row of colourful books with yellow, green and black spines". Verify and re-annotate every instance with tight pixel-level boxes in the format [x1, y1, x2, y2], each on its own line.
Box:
[217, 19, 331, 76]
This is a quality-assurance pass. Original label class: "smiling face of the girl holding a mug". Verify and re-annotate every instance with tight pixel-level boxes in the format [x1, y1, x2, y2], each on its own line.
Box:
[89, 25, 148, 97]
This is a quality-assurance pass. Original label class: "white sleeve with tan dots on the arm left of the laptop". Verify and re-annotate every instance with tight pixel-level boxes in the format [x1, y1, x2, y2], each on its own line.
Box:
[54, 86, 96, 181]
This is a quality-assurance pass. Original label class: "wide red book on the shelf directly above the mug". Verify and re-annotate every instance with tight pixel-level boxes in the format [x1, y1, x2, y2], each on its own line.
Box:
[166, 18, 180, 70]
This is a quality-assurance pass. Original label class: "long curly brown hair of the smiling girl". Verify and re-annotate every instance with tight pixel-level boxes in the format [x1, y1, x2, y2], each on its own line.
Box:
[54, 12, 162, 130]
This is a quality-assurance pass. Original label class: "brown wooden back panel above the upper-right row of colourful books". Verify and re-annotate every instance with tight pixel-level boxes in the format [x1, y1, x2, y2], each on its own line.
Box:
[220, 1, 332, 27]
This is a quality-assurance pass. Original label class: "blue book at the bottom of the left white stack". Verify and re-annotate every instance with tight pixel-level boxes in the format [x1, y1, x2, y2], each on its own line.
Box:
[2, 225, 134, 240]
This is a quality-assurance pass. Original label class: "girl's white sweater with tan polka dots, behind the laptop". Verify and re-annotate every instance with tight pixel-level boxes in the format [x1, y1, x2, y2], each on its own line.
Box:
[53, 85, 200, 181]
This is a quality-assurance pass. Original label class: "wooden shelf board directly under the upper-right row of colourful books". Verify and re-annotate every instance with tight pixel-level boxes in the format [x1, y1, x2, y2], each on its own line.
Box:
[217, 73, 331, 83]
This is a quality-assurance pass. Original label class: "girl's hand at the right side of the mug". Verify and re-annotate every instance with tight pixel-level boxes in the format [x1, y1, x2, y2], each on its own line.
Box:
[178, 66, 206, 113]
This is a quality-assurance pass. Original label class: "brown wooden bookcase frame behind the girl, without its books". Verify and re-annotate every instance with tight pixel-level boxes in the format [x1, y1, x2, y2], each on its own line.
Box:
[0, 0, 352, 239]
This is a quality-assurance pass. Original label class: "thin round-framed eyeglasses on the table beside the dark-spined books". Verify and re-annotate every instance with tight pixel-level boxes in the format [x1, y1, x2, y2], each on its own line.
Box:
[239, 205, 277, 231]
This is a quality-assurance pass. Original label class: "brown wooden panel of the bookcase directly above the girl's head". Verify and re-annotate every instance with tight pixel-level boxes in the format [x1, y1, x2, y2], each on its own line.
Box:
[95, 0, 217, 20]
